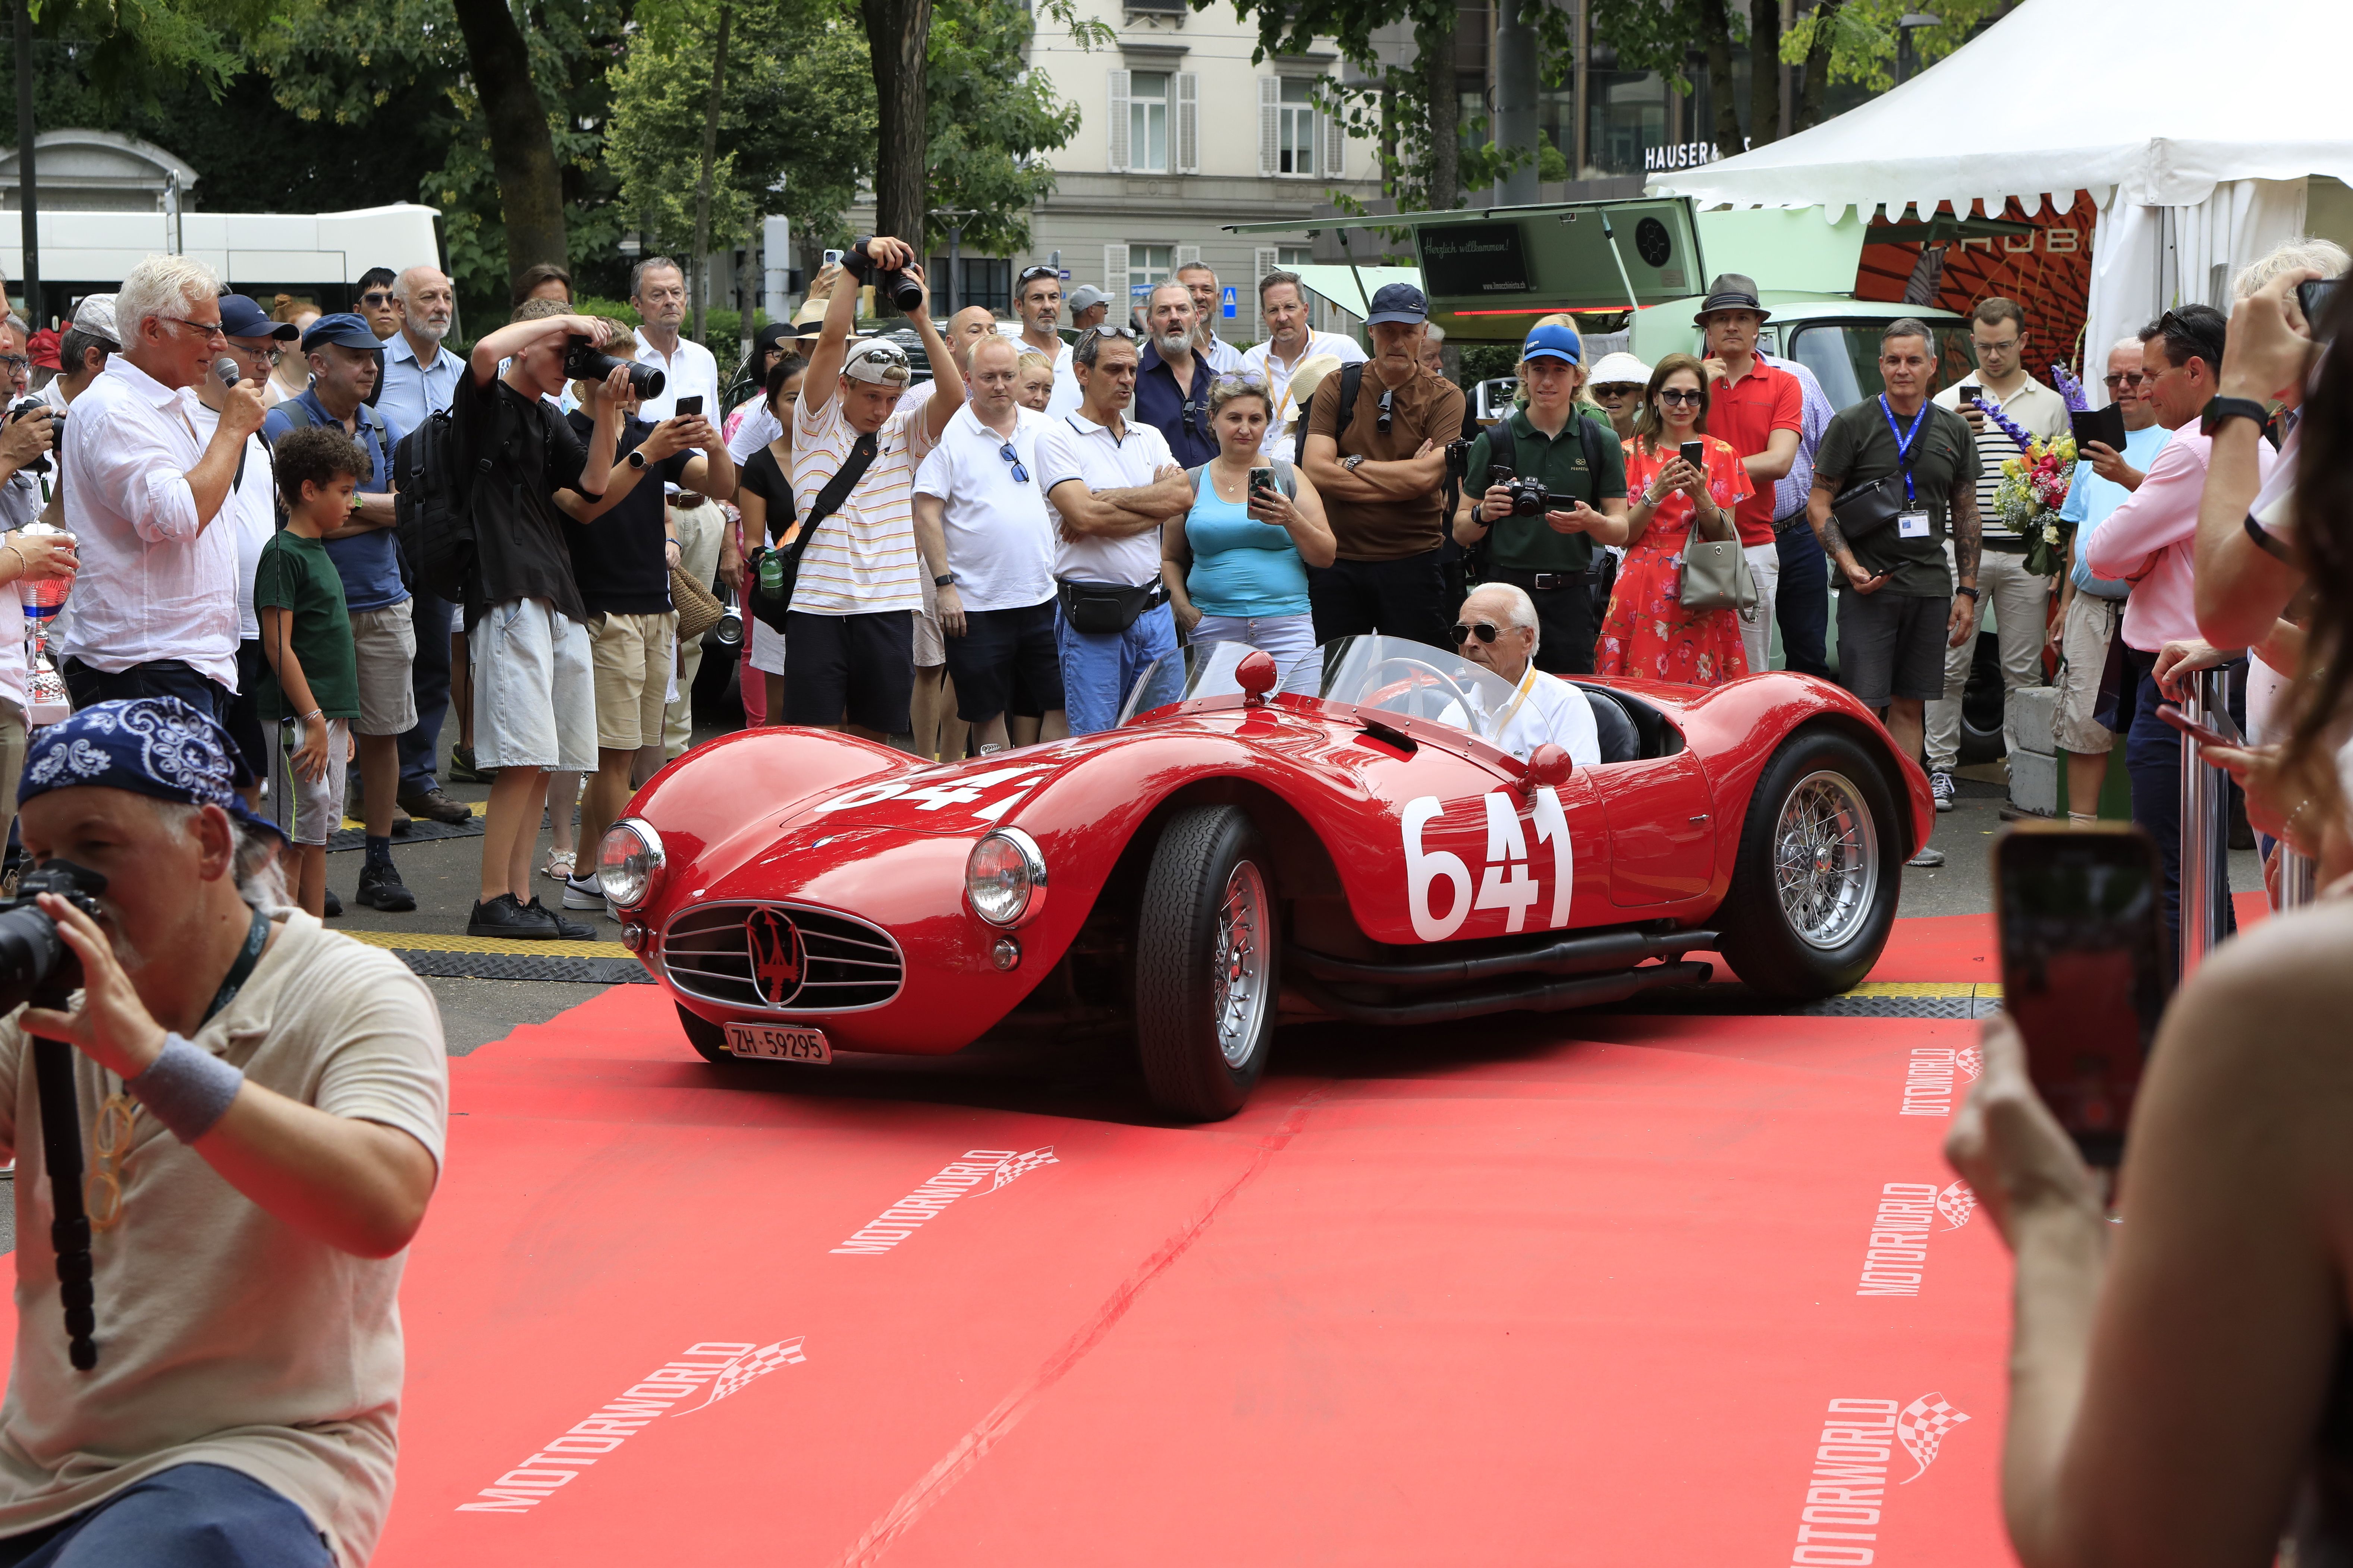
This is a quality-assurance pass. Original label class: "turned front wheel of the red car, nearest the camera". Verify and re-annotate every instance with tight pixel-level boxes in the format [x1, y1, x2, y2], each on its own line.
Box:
[1137, 806, 1282, 1121]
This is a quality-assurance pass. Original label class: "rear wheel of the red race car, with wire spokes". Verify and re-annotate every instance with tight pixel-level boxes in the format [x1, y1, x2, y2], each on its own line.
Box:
[1715, 729, 1904, 1001]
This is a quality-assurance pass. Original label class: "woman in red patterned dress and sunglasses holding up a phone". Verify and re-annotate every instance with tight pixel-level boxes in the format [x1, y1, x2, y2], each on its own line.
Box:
[1593, 355, 1751, 686]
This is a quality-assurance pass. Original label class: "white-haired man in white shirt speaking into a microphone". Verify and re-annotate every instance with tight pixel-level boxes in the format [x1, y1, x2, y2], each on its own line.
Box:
[59, 256, 266, 720]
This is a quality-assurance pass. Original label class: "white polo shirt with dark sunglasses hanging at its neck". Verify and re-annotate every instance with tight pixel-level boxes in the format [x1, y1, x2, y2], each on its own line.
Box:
[915, 402, 1054, 609]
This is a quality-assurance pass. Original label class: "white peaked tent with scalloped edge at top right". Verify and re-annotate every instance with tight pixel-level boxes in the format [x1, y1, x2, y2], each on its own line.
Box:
[1649, 0, 2353, 395]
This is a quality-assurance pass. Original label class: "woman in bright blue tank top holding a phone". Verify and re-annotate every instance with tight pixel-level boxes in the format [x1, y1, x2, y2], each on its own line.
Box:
[1160, 376, 1336, 693]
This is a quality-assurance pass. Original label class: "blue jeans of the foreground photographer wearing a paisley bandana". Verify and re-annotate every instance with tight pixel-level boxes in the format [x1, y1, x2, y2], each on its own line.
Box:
[0, 1465, 334, 1568]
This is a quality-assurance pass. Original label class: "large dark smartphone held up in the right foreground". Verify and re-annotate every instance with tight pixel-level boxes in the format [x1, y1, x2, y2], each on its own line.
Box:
[1993, 825, 2172, 1166]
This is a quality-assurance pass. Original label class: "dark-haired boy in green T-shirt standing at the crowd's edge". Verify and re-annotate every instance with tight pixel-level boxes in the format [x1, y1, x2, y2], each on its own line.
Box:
[254, 425, 365, 917]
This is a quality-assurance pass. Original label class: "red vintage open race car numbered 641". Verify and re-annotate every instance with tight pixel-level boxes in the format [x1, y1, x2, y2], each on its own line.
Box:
[600, 637, 1934, 1119]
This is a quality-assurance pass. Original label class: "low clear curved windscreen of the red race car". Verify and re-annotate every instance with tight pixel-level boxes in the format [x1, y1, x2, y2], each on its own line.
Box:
[1120, 637, 1513, 740]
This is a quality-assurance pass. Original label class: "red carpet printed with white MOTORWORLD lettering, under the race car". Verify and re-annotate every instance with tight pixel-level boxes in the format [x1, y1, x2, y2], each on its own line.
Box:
[358, 922, 2007, 1568]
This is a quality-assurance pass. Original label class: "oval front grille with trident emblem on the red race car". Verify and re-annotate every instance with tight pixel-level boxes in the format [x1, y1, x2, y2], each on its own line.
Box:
[661, 903, 906, 1013]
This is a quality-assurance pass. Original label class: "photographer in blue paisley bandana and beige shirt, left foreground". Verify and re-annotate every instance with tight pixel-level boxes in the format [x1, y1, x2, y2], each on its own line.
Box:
[0, 698, 449, 1568]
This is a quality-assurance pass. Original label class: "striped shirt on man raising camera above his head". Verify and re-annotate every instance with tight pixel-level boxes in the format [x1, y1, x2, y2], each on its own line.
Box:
[793, 390, 932, 616]
